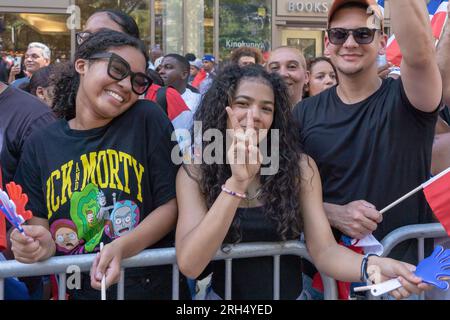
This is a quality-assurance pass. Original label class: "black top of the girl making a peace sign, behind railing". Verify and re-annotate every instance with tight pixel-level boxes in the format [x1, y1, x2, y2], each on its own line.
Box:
[210, 208, 302, 300]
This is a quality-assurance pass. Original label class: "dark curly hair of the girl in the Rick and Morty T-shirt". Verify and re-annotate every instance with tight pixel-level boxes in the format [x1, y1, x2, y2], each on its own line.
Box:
[52, 29, 148, 120]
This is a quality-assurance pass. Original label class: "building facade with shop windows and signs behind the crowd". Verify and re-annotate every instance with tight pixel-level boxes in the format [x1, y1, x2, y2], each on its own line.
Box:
[0, 0, 389, 60]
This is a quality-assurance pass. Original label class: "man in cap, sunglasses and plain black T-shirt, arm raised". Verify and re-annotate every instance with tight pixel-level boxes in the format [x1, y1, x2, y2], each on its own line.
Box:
[294, 0, 442, 300]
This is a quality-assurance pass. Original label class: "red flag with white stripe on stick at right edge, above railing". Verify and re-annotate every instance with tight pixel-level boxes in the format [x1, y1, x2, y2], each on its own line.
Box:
[422, 168, 450, 236]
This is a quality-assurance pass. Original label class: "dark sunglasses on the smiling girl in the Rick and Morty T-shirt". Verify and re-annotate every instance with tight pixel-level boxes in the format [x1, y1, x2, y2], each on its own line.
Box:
[89, 52, 153, 96]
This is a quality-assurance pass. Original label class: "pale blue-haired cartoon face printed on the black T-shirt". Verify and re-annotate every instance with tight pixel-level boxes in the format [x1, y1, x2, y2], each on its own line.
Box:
[105, 200, 139, 238]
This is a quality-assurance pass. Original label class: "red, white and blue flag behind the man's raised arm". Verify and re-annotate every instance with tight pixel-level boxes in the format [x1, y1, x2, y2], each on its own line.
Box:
[384, 0, 448, 66]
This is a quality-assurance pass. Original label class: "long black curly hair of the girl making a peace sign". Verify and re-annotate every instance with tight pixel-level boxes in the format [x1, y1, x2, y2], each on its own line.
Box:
[192, 65, 303, 243]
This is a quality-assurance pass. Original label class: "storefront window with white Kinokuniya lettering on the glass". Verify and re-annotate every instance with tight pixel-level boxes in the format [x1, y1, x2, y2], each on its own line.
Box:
[219, 0, 272, 60]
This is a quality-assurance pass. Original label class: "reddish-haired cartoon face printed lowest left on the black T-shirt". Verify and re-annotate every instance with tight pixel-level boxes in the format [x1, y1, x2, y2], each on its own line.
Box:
[50, 219, 84, 253]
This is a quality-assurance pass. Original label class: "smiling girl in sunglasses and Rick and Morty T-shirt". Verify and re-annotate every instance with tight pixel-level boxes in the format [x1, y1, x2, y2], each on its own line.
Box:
[11, 30, 187, 299]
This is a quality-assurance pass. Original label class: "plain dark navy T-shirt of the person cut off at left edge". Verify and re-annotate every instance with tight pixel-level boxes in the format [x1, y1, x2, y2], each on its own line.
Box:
[0, 86, 55, 184]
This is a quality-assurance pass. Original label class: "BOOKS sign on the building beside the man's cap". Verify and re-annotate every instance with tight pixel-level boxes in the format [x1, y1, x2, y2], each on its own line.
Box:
[277, 0, 332, 16]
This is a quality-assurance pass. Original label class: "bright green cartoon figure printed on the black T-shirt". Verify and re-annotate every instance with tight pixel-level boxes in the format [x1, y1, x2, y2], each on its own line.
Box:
[70, 183, 104, 252]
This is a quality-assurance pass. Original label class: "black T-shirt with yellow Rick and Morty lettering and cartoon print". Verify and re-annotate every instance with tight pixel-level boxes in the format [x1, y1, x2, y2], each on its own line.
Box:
[15, 100, 186, 298]
